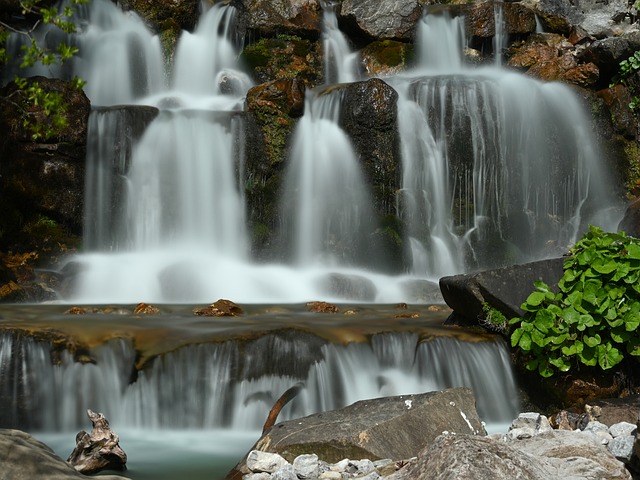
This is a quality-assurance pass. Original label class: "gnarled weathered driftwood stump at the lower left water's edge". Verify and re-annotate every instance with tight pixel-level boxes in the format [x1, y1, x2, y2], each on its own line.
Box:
[67, 410, 127, 474]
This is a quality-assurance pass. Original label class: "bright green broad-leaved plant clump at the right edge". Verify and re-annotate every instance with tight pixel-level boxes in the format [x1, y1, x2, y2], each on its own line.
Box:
[510, 227, 640, 377]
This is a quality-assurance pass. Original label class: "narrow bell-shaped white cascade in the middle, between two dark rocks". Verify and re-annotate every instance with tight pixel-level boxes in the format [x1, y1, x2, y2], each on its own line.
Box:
[282, 90, 373, 266]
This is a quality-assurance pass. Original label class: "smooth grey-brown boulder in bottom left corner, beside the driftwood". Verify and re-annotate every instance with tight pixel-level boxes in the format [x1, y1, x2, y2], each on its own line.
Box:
[0, 429, 126, 480]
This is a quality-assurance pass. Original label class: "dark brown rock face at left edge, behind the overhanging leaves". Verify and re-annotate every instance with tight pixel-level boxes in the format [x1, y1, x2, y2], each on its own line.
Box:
[0, 77, 90, 242]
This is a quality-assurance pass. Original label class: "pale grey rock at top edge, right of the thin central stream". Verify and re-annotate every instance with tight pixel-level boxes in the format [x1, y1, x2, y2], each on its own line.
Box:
[339, 0, 423, 40]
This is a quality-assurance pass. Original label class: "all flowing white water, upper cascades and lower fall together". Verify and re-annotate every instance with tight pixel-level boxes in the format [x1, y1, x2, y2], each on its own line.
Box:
[0, 0, 628, 480]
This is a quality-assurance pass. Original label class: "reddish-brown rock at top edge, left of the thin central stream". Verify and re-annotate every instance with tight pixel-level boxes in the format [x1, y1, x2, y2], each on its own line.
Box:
[241, 0, 322, 37]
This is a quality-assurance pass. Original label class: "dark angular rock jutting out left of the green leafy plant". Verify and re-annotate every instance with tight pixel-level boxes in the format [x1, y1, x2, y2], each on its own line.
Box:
[440, 257, 564, 324]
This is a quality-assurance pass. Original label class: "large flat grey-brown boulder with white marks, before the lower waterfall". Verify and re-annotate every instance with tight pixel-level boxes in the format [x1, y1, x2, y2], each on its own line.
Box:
[227, 388, 485, 478]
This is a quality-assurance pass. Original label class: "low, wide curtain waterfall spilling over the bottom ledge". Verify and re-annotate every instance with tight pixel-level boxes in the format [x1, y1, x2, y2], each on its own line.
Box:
[0, 333, 518, 431]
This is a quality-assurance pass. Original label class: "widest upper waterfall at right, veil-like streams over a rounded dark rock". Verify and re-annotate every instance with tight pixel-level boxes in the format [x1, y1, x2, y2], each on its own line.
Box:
[393, 11, 617, 278]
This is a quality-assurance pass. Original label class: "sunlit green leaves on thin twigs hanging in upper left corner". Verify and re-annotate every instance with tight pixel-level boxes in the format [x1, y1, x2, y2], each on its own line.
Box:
[0, 0, 88, 140]
